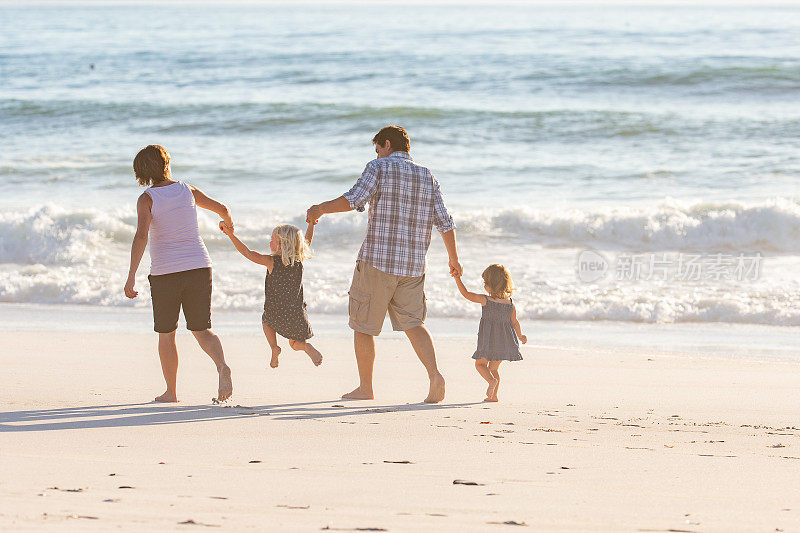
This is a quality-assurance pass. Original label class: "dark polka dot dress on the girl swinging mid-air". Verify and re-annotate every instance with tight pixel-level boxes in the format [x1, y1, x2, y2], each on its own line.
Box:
[261, 255, 314, 341]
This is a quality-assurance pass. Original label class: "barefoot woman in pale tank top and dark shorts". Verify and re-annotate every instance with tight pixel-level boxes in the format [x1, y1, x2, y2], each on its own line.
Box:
[124, 145, 233, 402]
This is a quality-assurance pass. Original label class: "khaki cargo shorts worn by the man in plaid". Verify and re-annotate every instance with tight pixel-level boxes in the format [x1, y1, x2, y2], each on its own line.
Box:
[349, 261, 428, 336]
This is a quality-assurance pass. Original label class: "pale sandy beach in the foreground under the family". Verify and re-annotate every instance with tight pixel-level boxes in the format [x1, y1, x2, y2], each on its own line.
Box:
[0, 331, 800, 532]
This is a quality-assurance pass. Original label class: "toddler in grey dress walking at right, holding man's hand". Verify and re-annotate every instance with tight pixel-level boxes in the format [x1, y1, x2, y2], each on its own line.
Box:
[454, 264, 528, 402]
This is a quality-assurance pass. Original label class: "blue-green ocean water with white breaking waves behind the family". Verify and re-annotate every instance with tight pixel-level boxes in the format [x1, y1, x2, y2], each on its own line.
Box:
[0, 4, 800, 326]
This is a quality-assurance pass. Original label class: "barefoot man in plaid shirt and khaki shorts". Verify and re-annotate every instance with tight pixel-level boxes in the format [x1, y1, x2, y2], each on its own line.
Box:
[307, 126, 462, 403]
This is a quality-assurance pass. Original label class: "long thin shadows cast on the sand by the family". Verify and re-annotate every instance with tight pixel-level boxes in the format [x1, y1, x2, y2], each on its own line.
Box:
[0, 400, 481, 433]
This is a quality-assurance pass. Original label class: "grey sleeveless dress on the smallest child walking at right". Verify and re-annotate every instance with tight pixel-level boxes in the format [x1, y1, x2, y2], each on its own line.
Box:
[472, 298, 522, 361]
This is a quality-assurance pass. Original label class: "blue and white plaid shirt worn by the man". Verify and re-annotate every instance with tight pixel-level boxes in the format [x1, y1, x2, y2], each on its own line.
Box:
[344, 152, 456, 277]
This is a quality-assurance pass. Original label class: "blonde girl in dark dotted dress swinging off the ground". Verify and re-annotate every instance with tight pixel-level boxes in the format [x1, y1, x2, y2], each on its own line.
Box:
[219, 220, 322, 368]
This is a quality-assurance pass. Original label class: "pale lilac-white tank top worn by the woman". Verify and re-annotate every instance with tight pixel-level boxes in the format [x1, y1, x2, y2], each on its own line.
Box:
[145, 181, 211, 276]
